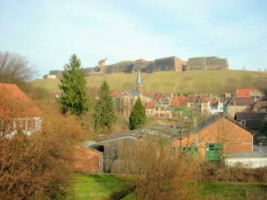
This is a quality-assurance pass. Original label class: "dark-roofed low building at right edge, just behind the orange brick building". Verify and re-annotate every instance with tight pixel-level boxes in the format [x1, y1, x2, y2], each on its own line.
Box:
[234, 112, 267, 131]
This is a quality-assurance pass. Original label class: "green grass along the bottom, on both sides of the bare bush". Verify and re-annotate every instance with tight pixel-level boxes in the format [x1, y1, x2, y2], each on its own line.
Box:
[67, 173, 267, 200]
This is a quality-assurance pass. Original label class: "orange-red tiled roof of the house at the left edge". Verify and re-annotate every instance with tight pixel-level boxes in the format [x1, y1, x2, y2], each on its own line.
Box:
[0, 83, 42, 117]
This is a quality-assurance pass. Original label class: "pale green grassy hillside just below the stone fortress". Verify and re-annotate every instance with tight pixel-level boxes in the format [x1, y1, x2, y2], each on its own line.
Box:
[33, 70, 267, 94]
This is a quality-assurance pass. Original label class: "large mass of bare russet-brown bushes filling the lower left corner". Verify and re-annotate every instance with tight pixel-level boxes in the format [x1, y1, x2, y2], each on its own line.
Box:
[0, 101, 84, 200]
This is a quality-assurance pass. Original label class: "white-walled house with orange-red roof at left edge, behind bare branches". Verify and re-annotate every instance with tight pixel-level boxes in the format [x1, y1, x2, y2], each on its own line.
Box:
[0, 83, 42, 136]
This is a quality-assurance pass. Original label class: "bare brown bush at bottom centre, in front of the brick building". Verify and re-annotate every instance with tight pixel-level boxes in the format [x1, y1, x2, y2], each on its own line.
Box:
[120, 137, 199, 200]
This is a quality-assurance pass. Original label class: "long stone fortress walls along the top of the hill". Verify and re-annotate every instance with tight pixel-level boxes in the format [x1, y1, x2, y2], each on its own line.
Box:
[44, 56, 229, 79]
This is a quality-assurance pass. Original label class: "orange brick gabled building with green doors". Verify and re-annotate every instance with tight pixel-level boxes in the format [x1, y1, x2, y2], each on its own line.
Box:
[173, 117, 253, 161]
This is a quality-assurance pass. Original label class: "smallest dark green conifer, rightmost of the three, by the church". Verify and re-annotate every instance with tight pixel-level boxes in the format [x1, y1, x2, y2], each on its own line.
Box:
[129, 97, 146, 130]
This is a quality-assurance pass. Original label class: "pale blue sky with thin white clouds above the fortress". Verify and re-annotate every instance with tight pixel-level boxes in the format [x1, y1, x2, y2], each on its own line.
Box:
[0, 0, 267, 78]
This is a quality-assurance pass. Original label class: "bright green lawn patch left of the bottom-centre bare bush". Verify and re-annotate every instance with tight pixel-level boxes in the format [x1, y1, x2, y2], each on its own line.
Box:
[67, 173, 130, 200]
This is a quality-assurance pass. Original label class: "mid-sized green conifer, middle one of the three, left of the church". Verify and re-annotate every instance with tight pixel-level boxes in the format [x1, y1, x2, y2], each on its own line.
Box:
[93, 81, 117, 134]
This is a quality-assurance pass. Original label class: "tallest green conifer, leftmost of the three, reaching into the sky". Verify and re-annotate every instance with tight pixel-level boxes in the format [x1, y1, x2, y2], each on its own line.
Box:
[58, 54, 88, 116]
